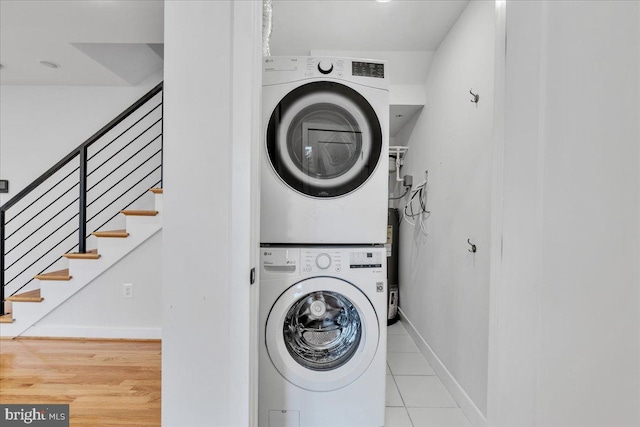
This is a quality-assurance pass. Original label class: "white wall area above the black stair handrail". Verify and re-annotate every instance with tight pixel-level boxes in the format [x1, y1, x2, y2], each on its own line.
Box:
[0, 73, 162, 204]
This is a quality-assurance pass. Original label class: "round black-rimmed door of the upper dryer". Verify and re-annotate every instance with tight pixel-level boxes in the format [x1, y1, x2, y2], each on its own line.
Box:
[266, 81, 382, 198]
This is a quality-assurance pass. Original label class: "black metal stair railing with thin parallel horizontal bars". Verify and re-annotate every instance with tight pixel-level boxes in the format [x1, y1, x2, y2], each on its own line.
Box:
[0, 82, 163, 315]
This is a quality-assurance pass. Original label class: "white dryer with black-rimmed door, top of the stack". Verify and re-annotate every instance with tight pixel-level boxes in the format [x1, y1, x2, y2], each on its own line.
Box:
[260, 57, 389, 244]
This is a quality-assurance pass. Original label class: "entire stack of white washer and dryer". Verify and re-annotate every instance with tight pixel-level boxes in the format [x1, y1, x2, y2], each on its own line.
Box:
[258, 57, 389, 427]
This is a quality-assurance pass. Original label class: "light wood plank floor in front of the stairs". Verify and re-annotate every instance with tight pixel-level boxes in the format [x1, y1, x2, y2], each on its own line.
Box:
[0, 339, 161, 427]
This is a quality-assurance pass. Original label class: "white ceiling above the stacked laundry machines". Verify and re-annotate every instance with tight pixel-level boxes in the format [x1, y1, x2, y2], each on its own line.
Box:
[271, 0, 469, 55]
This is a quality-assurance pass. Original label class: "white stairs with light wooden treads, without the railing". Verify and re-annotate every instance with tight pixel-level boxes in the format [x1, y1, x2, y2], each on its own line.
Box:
[0, 188, 163, 337]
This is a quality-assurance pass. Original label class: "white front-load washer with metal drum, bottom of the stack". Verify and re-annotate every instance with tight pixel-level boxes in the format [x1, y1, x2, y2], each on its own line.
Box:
[258, 246, 387, 427]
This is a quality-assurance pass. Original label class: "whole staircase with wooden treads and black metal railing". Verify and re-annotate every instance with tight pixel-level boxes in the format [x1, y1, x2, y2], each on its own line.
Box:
[0, 83, 163, 337]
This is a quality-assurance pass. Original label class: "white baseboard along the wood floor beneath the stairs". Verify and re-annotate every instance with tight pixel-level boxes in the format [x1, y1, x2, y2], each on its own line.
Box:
[21, 325, 162, 339]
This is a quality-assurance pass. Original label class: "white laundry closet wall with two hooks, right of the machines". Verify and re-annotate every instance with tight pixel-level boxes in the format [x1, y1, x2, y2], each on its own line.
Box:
[395, 1, 494, 420]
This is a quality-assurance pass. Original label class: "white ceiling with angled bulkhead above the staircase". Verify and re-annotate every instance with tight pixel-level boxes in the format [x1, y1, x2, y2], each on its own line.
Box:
[0, 0, 164, 86]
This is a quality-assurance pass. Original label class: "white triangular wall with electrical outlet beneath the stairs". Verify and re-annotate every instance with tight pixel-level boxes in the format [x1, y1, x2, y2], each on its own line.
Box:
[22, 232, 162, 339]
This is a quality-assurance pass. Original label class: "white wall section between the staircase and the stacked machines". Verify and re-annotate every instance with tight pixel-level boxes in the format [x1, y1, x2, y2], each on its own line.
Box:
[162, 1, 262, 427]
